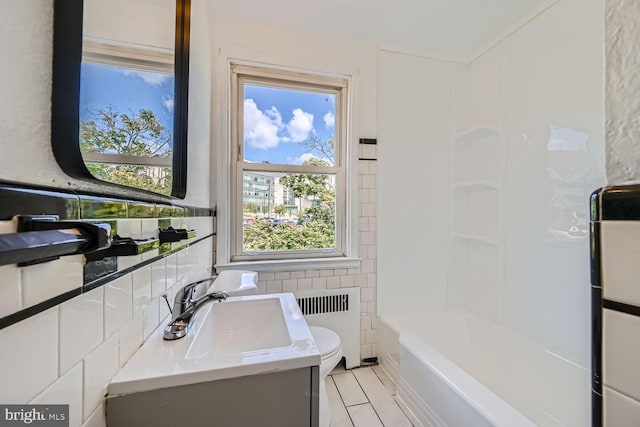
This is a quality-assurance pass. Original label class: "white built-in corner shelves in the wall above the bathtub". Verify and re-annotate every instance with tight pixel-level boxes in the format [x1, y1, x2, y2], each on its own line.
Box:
[448, 125, 504, 321]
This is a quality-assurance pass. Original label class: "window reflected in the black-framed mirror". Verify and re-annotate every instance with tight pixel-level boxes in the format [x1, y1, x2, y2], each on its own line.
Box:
[80, 42, 175, 196]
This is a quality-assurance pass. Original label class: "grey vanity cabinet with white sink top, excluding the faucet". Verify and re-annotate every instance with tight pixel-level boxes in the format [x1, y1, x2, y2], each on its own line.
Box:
[106, 293, 320, 427]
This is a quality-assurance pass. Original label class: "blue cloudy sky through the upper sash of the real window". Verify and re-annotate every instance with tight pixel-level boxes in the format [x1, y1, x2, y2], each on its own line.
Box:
[243, 84, 336, 164]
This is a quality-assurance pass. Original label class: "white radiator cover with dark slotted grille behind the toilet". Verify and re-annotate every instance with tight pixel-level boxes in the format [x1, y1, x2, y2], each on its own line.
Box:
[294, 288, 360, 369]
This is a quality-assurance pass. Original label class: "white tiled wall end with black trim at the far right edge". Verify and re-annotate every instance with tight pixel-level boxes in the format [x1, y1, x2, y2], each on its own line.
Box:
[591, 185, 640, 427]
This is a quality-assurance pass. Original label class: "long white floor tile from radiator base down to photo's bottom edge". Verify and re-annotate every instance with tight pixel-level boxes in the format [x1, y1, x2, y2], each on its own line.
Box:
[352, 368, 411, 427]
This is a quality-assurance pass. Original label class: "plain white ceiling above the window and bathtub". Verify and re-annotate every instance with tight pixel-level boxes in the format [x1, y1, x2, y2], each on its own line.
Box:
[209, 0, 554, 59]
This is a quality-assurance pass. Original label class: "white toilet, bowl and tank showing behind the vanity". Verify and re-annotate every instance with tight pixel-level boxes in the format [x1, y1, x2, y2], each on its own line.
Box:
[209, 270, 342, 427]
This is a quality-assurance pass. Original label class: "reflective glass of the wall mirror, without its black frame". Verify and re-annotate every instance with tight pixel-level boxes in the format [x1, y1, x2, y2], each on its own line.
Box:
[79, 0, 176, 195]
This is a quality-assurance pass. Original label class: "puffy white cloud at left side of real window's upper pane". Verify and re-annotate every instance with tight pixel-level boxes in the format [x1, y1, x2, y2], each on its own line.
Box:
[244, 99, 283, 150]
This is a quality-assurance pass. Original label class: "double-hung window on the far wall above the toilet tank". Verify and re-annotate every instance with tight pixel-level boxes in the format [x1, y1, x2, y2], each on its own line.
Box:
[229, 64, 350, 261]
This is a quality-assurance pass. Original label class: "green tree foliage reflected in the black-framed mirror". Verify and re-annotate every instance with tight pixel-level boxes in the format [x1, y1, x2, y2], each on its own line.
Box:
[80, 105, 173, 195]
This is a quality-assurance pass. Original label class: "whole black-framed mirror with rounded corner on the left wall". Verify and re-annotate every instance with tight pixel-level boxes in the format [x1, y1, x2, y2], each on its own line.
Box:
[52, 0, 190, 197]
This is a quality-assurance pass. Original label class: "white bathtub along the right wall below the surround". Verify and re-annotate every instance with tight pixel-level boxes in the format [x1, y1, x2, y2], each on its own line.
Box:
[377, 310, 591, 427]
